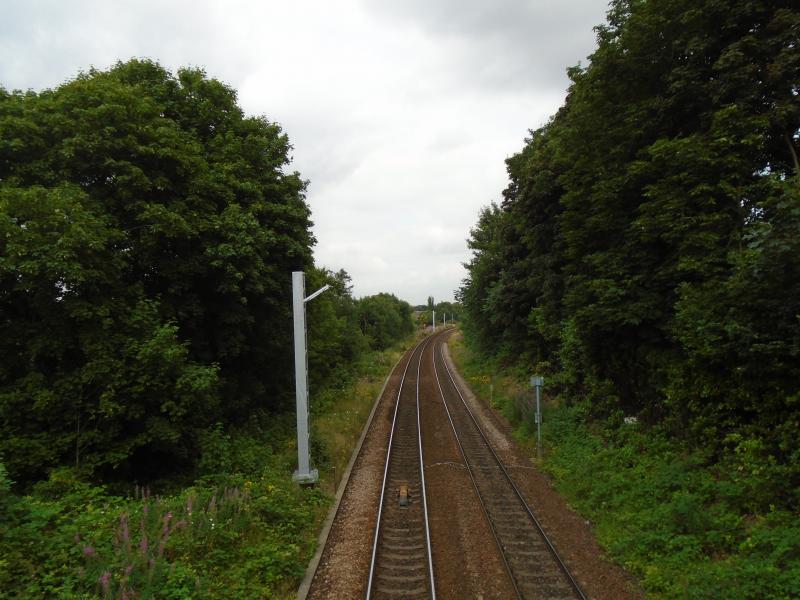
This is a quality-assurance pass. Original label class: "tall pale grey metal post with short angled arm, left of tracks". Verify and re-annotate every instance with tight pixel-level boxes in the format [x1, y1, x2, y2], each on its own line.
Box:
[292, 271, 331, 485]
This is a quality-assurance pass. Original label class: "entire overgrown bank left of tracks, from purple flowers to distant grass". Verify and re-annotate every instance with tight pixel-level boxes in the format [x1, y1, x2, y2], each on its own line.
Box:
[0, 346, 410, 599]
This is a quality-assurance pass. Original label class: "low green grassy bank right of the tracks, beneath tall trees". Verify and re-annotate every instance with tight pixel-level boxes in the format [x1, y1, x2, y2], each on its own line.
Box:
[451, 330, 800, 599]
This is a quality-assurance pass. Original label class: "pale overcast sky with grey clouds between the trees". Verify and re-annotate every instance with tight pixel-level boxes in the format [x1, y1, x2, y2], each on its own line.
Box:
[0, 0, 607, 304]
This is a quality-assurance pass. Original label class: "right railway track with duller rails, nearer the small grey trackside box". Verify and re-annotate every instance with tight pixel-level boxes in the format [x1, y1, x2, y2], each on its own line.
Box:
[431, 337, 585, 600]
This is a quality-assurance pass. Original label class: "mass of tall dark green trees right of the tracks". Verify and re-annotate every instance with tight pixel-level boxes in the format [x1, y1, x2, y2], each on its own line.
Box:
[460, 0, 800, 506]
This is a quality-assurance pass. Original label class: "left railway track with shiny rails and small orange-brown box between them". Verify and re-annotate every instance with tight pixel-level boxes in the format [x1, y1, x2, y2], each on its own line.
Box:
[366, 336, 440, 600]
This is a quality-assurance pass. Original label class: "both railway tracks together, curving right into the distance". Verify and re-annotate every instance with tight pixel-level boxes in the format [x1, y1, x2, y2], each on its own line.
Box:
[366, 333, 585, 600]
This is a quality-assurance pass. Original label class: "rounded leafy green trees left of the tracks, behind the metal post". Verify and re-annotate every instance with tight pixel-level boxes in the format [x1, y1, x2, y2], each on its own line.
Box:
[0, 60, 413, 483]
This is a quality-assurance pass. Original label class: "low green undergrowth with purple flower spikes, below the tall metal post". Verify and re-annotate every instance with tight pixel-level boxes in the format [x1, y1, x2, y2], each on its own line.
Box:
[0, 460, 323, 598]
